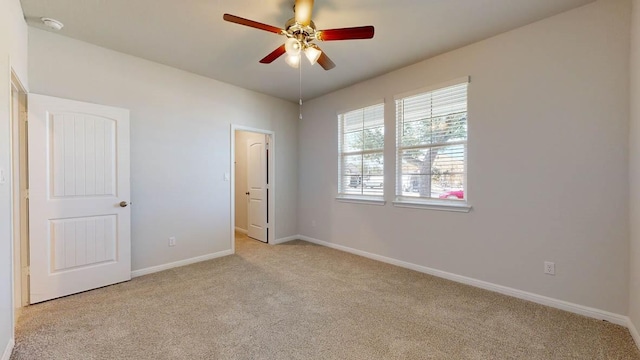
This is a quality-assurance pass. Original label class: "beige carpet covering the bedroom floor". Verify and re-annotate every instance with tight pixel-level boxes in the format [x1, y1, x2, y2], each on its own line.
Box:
[11, 233, 640, 360]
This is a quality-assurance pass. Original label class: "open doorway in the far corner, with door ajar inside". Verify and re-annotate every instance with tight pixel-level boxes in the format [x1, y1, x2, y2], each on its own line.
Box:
[231, 126, 275, 251]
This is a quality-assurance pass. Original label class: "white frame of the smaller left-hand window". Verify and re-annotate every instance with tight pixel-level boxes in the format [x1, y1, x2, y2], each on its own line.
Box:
[336, 99, 387, 205]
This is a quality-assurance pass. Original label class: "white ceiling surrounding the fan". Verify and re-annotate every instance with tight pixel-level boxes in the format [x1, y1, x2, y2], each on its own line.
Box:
[21, 0, 594, 101]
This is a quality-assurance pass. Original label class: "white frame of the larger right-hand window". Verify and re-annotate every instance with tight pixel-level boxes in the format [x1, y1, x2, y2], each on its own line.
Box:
[393, 76, 471, 212]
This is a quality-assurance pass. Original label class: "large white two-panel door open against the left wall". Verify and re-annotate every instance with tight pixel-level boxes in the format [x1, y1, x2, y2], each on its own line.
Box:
[29, 94, 131, 304]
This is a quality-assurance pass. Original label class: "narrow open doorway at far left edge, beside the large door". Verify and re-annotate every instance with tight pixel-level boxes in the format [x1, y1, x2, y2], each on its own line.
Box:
[11, 72, 29, 318]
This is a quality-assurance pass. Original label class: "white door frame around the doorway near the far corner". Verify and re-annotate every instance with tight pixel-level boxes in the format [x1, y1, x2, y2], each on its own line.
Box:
[229, 124, 276, 254]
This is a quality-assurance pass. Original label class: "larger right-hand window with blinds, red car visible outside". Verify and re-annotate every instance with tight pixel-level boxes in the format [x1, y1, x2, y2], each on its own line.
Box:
[396, 79, 468, 205]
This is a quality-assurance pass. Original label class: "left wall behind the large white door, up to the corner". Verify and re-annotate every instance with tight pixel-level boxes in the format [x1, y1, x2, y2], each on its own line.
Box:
[29, 28, 298, 270]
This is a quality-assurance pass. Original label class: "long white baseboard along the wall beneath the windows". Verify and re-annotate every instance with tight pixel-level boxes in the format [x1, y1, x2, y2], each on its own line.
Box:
[298, 235, 624, 328]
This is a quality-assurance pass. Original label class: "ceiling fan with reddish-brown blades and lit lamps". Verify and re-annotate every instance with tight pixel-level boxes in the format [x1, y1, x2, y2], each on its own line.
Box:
[222, 0, 374, 70]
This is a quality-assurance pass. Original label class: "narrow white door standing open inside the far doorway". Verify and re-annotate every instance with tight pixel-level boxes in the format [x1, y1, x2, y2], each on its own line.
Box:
[247, 135, 268, 242]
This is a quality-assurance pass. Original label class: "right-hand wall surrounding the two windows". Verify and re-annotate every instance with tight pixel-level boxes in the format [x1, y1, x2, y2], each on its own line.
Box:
[298, 0, 630, 314]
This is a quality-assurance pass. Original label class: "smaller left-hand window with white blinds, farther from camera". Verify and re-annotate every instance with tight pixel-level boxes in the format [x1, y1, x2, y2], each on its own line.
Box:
[338, 104, 384, 199]
